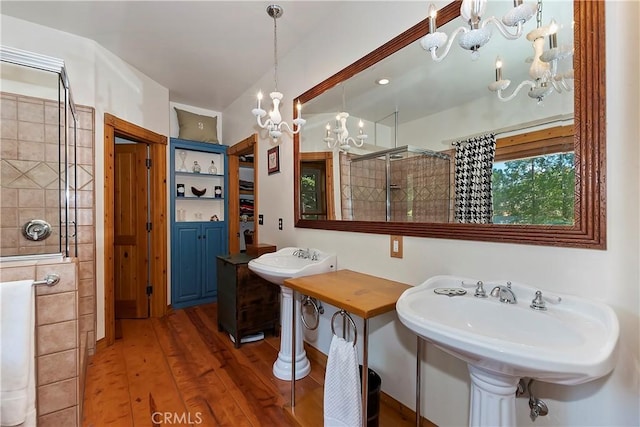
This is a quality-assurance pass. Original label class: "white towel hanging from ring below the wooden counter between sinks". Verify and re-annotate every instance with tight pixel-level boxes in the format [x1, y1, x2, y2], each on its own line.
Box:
[324, 335, 362, 427]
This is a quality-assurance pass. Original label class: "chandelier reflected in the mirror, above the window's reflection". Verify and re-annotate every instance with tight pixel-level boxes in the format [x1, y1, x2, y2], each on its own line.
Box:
[489, 0, 573, 102]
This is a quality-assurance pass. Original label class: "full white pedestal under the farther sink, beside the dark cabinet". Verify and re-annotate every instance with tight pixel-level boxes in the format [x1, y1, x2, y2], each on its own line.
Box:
[273, 286, 311, 381]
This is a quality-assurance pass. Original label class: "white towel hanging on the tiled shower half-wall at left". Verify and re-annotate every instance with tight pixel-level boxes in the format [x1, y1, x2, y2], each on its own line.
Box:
[0, 280, 36, 426]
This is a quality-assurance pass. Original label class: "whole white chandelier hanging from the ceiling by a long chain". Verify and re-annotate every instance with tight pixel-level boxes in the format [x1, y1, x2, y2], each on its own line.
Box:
[251, 4, 307, 143]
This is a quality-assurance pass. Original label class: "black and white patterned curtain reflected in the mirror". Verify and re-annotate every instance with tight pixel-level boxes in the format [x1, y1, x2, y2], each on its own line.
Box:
[454, 133, 496, 224]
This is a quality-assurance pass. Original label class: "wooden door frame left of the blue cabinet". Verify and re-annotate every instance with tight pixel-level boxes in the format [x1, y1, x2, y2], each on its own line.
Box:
[104, 113, 167, 345]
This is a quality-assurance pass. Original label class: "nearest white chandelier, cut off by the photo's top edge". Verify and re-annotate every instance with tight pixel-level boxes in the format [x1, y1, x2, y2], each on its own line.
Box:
[420, 0, 537, 62]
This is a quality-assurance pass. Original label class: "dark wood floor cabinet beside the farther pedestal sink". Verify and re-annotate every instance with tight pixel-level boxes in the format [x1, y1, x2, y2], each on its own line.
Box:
[217, 254, 280, 348]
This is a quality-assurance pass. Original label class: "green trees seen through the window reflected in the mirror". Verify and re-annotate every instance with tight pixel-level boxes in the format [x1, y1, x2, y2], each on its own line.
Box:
[492, 152, 575, 225]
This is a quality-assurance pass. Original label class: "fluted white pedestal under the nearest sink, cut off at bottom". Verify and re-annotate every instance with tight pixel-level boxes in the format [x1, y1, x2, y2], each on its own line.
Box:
[468, 365, 520, 427]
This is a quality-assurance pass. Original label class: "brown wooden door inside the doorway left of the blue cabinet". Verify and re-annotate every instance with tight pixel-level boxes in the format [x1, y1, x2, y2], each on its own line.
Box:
[114, 144, 149, 319]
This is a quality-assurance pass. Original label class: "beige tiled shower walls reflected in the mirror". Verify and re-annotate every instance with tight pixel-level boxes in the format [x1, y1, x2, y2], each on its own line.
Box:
[340, 154, 453, 222]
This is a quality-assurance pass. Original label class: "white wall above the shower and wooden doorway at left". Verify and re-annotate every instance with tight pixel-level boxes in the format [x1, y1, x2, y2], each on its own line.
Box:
[0, 15, 169, 339]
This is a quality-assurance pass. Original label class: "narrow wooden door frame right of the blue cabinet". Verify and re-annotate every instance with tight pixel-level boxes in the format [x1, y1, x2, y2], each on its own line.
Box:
[227, 133, 259, 254]
